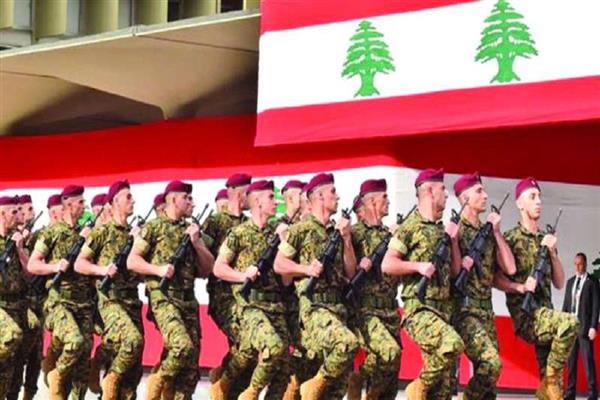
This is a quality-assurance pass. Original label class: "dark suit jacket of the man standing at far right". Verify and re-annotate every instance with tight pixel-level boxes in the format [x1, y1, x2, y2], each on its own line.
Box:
[563, 273, 600, 337]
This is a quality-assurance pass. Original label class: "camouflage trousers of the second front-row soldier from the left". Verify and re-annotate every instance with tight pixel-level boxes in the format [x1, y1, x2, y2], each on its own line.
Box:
[44, 297, 94, 400]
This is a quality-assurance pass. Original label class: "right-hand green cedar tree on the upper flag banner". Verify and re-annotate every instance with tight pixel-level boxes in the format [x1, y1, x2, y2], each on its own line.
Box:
[475, 0, 538, 83]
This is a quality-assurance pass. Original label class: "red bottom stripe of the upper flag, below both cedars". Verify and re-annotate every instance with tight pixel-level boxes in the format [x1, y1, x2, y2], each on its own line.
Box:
[256, 76, 600, 146]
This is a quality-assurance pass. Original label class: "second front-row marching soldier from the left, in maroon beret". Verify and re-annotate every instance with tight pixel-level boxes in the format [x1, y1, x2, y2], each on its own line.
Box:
[27, 185, 95, 400]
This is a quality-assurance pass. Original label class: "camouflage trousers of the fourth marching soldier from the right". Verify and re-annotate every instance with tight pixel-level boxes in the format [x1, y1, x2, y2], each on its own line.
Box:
[355, 308, 402, 400]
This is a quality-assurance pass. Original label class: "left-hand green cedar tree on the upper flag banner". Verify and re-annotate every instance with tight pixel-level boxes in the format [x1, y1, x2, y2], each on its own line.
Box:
[342, 20, 396, 97]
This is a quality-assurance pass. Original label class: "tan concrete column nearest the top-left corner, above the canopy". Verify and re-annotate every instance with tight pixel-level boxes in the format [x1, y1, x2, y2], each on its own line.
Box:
[33, 0, 67, 41]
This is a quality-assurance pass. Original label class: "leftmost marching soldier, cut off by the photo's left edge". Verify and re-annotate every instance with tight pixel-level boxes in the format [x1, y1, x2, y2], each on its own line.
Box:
[0, 196, 29, 399]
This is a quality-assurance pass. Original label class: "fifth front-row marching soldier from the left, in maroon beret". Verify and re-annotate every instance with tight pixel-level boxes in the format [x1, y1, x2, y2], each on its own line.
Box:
[211, 180, 289, 400]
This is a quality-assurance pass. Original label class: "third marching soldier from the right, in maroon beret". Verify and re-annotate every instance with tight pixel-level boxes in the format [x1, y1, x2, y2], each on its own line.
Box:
[382, 169, 464, 400]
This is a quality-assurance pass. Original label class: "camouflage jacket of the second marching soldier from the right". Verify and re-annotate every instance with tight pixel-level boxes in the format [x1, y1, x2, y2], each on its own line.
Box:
[458, 217, 497, 300]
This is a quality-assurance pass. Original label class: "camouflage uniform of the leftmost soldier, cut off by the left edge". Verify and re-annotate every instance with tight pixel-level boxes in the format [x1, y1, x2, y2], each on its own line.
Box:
[0, 232, 28, 399]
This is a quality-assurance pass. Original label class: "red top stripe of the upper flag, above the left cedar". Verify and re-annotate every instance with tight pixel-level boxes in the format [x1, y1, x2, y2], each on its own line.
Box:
[260, 0, 475, 33]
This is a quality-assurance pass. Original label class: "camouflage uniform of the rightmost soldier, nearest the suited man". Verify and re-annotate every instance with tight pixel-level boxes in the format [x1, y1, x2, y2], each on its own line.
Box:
[504, 224, 579, 376]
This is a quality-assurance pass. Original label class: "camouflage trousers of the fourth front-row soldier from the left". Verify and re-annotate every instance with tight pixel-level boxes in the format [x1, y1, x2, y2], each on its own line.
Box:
[150, 290, 200, 399]
